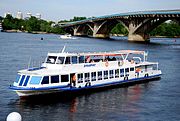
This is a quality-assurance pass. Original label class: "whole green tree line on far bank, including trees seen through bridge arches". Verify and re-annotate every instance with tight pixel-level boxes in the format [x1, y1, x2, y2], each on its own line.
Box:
[0, 15, 180, 37]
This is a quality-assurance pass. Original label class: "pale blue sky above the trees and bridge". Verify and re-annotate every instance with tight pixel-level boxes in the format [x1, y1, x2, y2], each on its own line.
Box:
[0, 0, 180, 22]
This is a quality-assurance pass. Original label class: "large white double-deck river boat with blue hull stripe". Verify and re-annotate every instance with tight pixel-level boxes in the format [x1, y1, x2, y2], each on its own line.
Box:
[10, 50, 161, 97]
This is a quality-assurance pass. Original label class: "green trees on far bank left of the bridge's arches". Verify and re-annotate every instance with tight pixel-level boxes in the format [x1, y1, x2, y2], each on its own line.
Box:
[0, 14, 86, 34]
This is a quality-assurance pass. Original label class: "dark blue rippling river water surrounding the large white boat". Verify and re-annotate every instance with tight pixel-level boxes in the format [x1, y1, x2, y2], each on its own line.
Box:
[0, 32, 180, 121]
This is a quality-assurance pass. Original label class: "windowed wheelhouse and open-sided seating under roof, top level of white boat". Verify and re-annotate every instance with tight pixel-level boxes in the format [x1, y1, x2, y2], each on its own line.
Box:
[45, 50, 147, 64]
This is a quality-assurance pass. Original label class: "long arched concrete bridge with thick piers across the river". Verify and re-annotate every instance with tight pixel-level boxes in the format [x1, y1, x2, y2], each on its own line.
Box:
[59, 10, 180, 41]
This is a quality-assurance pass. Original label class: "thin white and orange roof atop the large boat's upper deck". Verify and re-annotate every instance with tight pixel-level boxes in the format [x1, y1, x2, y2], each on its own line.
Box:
[48, 50, 145, 56]
